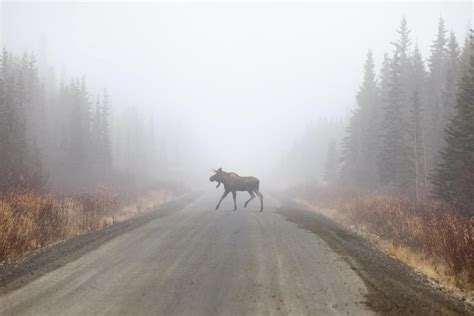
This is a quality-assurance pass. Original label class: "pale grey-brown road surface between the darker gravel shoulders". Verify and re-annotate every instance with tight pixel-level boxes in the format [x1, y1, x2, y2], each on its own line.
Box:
[0, 194, 370, 315]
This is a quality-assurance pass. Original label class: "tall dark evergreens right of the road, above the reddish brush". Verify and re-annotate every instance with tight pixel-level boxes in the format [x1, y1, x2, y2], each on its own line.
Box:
[336, 18, 474, 214]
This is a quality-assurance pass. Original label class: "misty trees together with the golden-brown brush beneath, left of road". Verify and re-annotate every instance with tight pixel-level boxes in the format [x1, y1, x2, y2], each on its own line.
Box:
[0, 48, 189, 261]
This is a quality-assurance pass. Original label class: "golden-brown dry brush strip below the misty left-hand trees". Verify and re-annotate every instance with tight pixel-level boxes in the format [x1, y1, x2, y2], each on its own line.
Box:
[0, 186, 181, 261]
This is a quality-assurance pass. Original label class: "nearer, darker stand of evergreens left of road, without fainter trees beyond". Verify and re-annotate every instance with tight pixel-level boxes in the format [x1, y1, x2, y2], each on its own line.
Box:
[0, 49, 126, 193]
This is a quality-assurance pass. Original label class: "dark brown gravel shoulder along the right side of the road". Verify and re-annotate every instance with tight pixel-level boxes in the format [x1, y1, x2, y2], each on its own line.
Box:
[272, 194, 474, 315]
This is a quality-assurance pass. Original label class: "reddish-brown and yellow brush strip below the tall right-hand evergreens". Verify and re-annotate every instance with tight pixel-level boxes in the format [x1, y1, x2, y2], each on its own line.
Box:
[294, 187, 474, 291]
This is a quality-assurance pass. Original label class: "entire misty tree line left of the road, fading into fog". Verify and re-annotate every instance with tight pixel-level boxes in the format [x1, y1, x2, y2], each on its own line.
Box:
[0, 49, 169, 193]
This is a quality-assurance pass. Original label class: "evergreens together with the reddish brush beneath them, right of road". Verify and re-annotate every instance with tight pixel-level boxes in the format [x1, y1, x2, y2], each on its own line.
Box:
[287, 18, 474, 295]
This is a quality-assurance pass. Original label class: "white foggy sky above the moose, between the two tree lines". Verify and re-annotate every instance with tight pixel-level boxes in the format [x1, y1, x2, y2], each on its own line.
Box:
[0, 1, 473, 189]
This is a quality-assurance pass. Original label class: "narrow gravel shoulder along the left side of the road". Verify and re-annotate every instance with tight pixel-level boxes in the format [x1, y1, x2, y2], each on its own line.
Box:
[0, 191, 203, 295]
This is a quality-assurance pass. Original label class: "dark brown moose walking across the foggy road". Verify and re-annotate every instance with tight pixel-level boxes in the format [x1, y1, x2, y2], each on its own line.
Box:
[209, 168, 263, 212]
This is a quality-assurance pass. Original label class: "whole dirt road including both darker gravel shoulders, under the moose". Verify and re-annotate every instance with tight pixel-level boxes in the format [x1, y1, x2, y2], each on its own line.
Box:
[0, 193, 468, 315]
